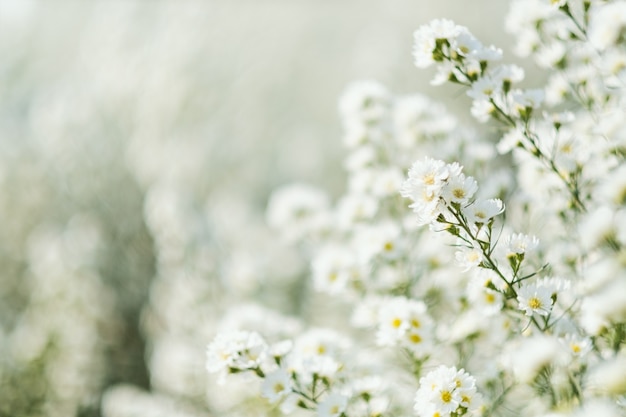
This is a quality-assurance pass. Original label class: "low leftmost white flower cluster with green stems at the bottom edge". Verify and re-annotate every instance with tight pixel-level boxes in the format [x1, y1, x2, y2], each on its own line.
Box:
[207, 328, 389, 417]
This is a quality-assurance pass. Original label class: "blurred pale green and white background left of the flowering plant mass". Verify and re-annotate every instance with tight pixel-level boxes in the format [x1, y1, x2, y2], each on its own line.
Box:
[0, 0, 514, 416]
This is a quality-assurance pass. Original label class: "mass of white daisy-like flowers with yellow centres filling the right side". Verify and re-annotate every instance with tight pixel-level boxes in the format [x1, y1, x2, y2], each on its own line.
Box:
[207, 0, 626, 417]
